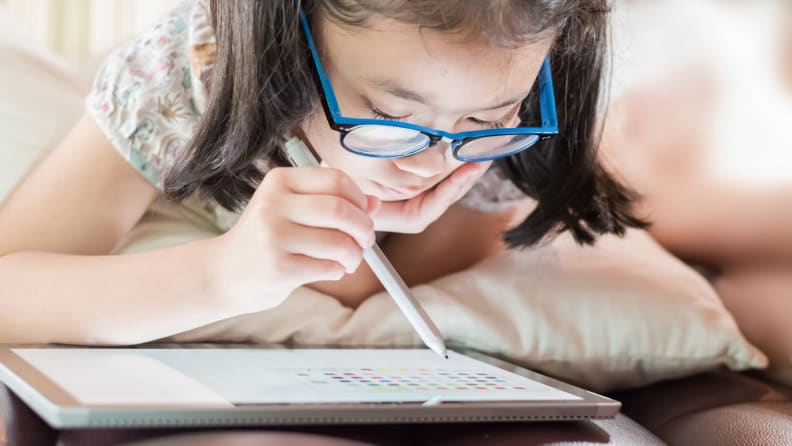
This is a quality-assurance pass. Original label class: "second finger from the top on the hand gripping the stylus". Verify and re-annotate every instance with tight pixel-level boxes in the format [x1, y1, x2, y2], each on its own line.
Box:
[281, 194, 374, 248]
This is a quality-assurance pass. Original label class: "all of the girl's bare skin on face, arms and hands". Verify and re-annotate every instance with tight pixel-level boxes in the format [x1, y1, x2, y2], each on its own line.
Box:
[0, 13, 550, 345]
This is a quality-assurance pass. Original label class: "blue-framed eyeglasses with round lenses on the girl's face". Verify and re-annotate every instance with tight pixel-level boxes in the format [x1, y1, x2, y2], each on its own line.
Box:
[300, 10, 558, 162]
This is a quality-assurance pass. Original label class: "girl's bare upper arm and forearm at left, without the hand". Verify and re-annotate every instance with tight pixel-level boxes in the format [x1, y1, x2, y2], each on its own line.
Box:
[0, 117, 231, 344]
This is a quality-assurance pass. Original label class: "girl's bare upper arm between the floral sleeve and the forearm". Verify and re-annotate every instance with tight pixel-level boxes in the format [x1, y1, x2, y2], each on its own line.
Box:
[0, 115, 157, 255]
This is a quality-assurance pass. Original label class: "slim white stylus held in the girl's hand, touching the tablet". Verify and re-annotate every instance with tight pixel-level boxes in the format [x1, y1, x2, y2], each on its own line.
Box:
[285, 136, 448, 358]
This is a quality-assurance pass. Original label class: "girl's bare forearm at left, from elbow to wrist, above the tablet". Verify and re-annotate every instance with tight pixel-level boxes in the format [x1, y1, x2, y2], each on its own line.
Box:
[0, 240, 239, 345]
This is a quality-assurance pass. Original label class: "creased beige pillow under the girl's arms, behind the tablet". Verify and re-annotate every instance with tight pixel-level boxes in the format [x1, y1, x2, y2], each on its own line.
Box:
[131, 205, 767, 391]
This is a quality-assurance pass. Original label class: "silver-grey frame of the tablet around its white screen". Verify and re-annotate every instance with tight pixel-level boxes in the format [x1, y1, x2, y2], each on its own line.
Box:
[0, 344, 621, 429]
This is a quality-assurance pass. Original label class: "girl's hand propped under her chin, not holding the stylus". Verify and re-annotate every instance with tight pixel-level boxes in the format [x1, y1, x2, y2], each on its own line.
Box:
[372, 161, 492, 234]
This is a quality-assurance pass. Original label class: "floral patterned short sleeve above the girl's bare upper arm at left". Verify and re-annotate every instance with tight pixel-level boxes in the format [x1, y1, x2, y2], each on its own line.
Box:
[86, 1, 213, 190]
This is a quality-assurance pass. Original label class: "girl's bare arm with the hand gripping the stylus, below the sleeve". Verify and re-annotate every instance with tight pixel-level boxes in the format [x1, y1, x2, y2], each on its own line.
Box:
[0, 118, 374, 344]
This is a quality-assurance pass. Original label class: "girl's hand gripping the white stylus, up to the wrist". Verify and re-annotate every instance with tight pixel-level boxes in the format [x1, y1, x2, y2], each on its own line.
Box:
[204, 167, 378, 312]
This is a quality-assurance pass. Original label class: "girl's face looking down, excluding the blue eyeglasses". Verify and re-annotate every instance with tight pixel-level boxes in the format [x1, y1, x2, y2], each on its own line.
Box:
[305, 18, 551, 201]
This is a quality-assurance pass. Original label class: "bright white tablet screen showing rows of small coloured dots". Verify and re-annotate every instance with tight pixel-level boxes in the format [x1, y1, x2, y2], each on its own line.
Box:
[12, 348, 581, 407]
